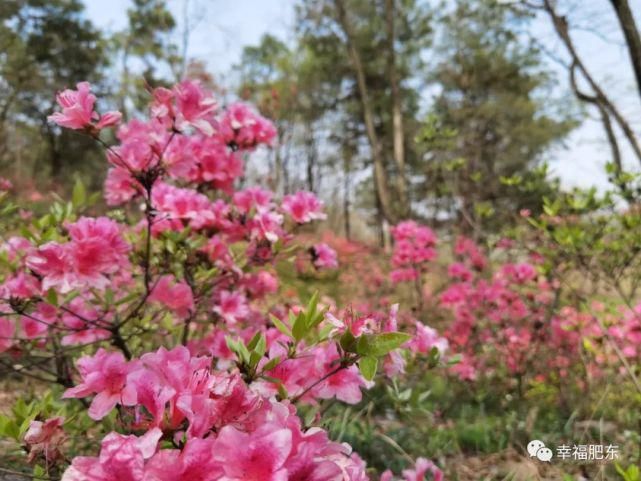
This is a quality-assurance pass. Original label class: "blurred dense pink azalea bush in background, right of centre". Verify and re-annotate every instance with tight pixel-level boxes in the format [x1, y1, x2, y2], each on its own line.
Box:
[439, 238, 554, 379]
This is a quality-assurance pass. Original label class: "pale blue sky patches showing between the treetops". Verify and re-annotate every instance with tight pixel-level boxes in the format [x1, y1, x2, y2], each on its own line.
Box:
[85, 0, 641, 191]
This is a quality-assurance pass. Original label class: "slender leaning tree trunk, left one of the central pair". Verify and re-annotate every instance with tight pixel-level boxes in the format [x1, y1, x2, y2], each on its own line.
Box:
[334, 0, 396, 223]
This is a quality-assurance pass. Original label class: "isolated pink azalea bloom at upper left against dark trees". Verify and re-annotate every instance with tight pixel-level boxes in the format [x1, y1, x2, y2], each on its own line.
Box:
[48, 82, 122, 130]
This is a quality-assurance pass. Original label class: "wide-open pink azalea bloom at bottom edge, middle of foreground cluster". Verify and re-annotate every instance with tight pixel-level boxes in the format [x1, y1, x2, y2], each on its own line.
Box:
[214, 425, 292, 481]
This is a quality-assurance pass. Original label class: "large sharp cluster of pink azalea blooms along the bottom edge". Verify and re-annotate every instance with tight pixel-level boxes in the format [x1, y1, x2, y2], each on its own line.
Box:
[63, 347, 366, 481]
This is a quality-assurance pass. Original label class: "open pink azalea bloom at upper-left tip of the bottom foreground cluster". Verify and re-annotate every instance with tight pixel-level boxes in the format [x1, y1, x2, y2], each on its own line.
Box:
[63, 348, 137, 420]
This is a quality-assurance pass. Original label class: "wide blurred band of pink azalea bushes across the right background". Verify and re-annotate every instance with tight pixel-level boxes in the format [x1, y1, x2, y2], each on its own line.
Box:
[390, 225, 620, 389]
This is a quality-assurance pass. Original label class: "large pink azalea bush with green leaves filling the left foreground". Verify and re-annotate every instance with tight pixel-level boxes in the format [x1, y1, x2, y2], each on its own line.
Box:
[0, 80, 442, 481]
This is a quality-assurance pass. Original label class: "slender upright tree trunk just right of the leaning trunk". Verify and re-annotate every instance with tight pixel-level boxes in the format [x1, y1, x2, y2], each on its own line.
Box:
[385, 0, 410, 217]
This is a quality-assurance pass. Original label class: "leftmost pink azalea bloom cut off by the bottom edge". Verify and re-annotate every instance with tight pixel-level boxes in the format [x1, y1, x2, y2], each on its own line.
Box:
[62, 428, 162, 481]
